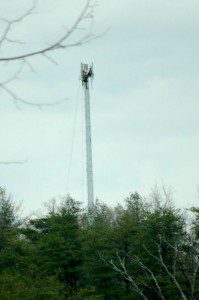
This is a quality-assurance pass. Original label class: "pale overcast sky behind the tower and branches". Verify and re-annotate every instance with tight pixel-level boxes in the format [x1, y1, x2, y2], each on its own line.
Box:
[0, 0, 199, 212]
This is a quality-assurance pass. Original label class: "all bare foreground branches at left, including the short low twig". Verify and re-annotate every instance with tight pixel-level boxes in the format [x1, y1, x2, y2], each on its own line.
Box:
[0, 0, 98, 164]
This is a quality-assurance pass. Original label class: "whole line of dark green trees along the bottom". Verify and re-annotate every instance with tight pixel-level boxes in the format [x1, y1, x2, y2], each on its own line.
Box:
[0, 188, 199, 300]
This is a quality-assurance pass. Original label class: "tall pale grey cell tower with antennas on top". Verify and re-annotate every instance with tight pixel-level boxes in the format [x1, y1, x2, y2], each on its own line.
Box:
[81, 64, 94, 211]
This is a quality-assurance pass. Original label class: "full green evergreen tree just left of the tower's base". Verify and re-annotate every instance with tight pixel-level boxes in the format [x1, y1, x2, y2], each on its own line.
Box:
[23, 197, 82, 294]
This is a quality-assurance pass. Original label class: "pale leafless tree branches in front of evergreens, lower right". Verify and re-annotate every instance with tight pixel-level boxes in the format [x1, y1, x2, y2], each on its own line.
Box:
[100, 238, 199, 300]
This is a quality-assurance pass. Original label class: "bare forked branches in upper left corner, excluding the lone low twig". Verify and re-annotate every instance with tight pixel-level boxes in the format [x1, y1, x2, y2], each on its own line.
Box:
[0, 0, 99, 109]
